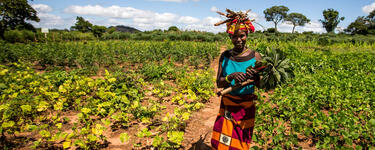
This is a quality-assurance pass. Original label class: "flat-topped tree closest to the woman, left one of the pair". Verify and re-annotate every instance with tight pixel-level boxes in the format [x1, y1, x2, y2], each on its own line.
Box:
[263, 6, 289, 32]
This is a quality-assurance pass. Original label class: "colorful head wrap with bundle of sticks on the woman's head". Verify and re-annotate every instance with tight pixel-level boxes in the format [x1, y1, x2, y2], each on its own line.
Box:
[215, 9, 255, 34]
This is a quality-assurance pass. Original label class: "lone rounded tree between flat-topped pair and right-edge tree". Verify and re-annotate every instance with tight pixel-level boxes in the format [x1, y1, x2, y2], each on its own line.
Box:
[320, 8, 345, 33]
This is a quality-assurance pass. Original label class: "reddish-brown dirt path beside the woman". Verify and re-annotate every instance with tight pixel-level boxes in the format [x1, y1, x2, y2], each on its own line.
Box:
[182, 46, 226, 150]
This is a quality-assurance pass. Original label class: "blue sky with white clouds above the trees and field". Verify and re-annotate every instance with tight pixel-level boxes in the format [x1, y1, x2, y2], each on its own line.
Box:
[29, 0, 375, 33]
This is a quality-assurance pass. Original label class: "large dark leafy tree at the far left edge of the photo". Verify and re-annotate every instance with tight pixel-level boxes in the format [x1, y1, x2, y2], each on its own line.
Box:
[0, 0, 40, 38]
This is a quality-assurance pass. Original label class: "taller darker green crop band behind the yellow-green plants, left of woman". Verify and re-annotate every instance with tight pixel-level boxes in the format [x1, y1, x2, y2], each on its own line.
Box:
[0, 41, 219, 71]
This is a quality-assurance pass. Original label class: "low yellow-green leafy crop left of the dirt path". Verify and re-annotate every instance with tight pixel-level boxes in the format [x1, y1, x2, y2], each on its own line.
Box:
[0, 63, 213, 149]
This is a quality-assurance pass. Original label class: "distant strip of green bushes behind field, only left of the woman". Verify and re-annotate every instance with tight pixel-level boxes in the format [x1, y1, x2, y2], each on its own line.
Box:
[5, 30, 227, 43]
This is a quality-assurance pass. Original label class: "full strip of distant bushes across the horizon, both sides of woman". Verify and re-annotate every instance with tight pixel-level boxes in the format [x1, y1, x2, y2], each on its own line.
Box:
[4, 29, 375, 46]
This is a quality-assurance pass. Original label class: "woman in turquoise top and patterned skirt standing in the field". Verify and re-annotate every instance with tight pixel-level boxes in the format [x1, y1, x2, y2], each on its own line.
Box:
[211, 10, 261, 150]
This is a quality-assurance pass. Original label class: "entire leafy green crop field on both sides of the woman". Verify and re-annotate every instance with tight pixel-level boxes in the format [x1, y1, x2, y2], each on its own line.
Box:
[0, 39, 375, 149]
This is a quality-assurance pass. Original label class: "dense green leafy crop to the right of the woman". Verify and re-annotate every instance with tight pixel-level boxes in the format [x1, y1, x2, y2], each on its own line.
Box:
[254, 45, 375, 149]
